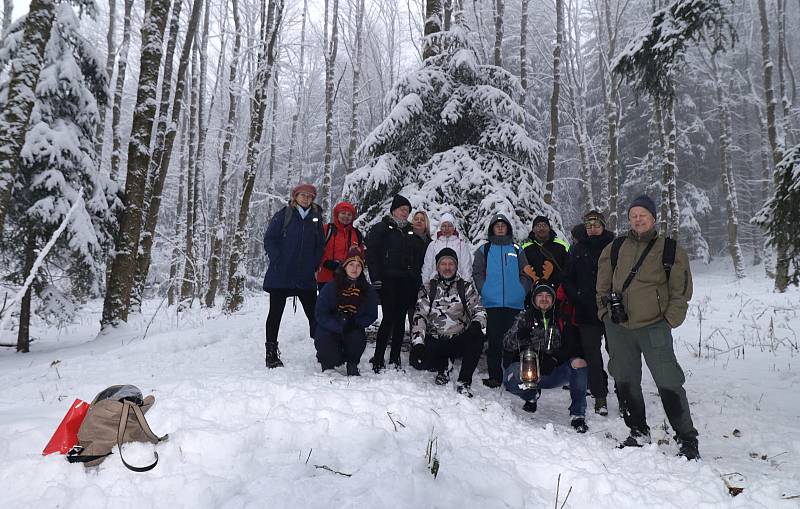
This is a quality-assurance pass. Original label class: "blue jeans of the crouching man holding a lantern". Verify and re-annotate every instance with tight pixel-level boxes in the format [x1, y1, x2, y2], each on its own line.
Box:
[503, 359, 587, 417]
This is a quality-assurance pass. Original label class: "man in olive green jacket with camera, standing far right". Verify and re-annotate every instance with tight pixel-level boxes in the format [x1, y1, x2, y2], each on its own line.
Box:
[597, 196, 700, 459]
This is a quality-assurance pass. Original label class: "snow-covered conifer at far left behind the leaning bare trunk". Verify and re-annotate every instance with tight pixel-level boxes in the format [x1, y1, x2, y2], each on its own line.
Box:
[0, 3, 120, 352]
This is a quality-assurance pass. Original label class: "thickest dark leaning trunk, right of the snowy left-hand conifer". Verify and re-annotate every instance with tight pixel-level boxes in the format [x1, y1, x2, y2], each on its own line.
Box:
[101, 0, 169, 328]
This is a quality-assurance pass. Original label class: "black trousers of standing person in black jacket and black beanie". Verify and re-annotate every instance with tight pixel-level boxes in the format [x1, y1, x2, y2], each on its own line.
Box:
[373, 279, 418, 365]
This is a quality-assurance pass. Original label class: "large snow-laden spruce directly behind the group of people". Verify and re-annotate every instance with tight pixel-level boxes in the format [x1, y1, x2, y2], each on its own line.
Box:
[344, 13, 561, 242]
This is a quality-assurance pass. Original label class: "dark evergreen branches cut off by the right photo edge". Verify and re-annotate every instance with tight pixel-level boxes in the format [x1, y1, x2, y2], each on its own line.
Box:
[753, 144, 800, 291]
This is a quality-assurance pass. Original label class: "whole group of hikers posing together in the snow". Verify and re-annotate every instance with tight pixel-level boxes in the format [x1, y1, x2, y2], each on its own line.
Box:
[264, 184, 699, 459]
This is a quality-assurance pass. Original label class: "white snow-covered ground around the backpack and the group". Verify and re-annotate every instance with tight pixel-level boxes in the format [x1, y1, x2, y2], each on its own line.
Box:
[0, 265, 800, 509]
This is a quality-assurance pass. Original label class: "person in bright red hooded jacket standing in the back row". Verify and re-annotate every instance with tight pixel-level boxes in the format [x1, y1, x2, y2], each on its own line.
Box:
[317, 201, 364, 290]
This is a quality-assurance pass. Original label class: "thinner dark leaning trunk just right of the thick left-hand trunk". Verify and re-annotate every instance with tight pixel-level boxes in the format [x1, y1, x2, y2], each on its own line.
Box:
[133, 0, 203, 310]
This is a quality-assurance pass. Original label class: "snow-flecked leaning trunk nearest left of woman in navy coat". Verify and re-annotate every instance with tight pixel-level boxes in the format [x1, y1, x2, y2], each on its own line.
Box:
[225, 0, 284, 313]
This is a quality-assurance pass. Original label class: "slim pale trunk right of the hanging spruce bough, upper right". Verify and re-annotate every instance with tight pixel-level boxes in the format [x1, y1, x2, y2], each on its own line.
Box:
[711, 53, 745, 279]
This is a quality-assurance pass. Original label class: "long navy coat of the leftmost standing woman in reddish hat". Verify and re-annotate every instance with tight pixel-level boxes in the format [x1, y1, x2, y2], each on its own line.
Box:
[264, 205, 325, 291]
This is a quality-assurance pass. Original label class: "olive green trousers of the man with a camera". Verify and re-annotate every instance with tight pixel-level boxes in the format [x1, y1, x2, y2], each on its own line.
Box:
[605, 320, 697, 440]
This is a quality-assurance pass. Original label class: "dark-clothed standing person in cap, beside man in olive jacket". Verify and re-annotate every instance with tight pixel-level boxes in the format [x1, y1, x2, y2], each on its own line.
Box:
[561, 210, 614, 415]
